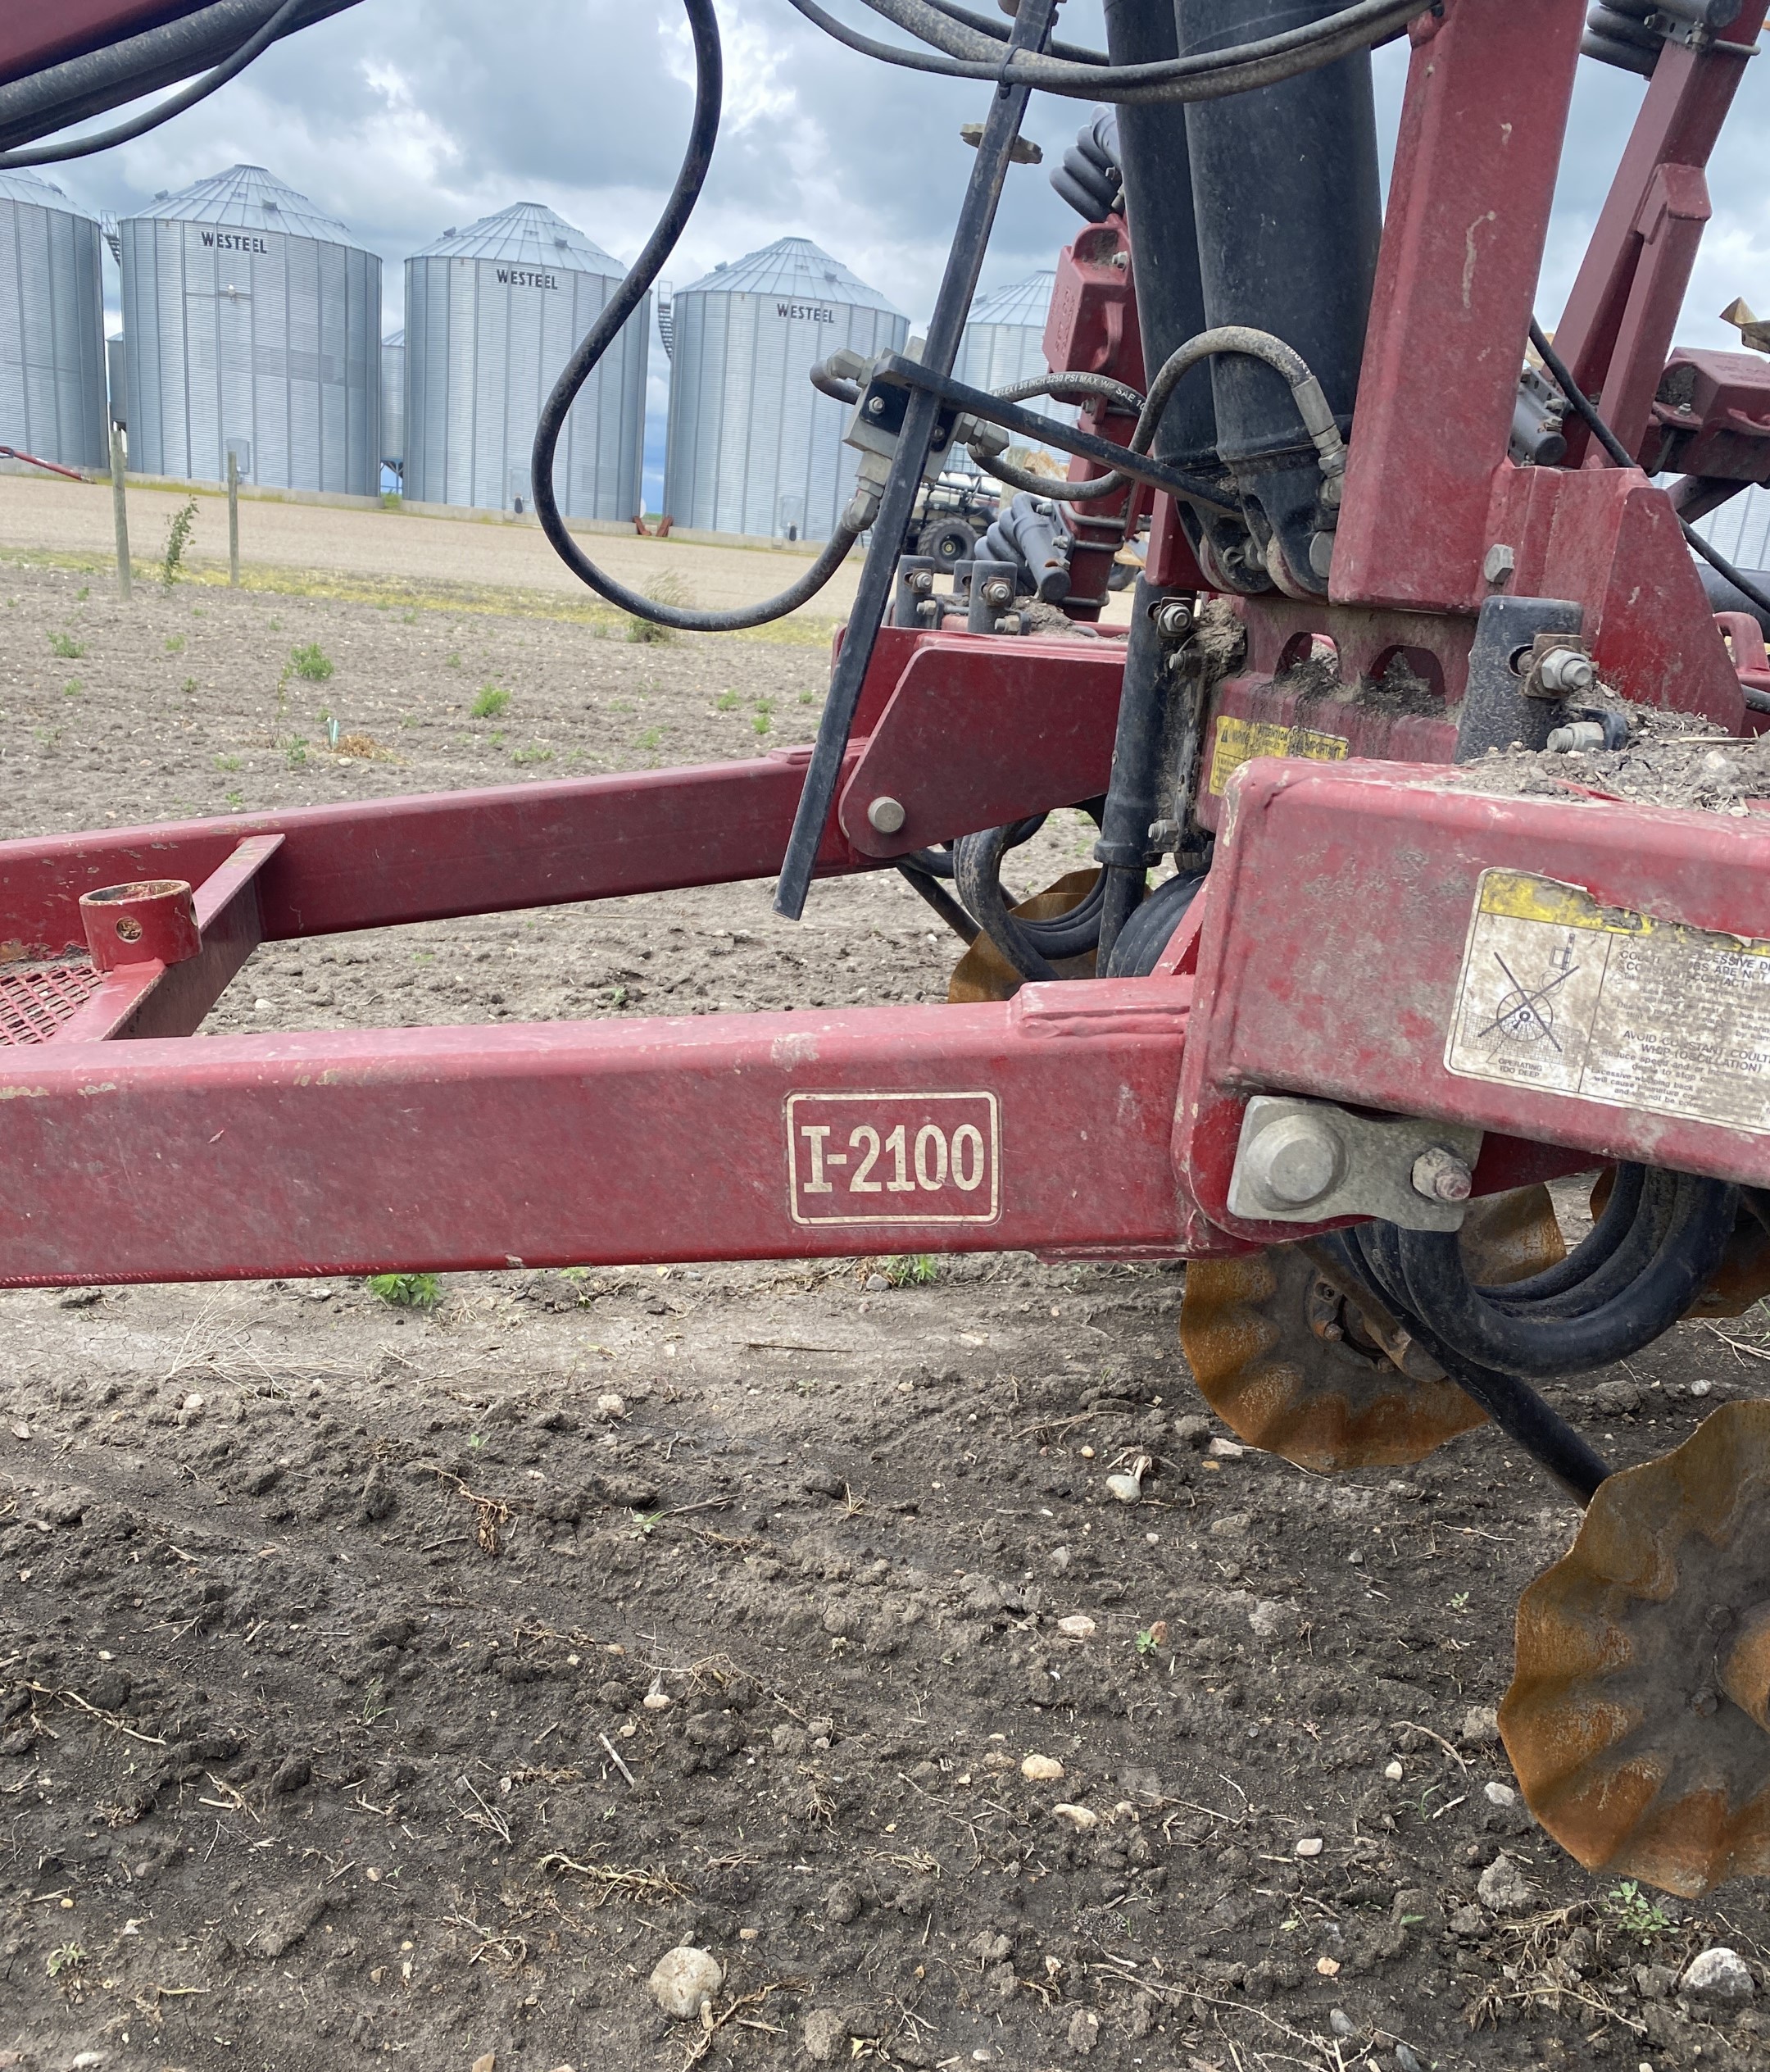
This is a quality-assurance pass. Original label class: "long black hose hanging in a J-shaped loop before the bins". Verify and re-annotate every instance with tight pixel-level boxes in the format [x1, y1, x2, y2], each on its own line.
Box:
[530, 0, 860, 634]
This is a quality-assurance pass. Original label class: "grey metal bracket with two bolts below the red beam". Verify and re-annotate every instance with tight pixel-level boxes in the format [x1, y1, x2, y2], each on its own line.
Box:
[1229, 1094, 1482, 1231]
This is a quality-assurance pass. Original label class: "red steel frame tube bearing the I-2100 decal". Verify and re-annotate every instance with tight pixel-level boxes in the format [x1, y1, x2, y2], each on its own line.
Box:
[0, 978, 1191, 1284]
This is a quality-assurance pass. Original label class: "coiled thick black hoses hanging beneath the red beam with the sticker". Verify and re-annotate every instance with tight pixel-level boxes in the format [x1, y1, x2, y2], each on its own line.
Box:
[1347, 1165, 1739, 1376]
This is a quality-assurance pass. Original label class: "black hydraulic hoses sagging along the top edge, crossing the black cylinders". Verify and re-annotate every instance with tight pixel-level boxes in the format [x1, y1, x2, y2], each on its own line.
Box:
[792, 0, 1430, 103]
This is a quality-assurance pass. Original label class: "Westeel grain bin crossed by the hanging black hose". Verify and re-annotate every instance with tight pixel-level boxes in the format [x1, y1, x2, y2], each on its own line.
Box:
[406, 201, 651, 520]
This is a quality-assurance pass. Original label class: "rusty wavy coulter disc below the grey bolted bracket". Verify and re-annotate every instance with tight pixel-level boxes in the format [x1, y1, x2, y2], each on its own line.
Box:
[1179, 1188, 1565, 1475]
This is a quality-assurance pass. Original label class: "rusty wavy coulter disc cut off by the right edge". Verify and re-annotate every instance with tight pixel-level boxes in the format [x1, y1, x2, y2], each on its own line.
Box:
[1500, 1402, 1770, 1898]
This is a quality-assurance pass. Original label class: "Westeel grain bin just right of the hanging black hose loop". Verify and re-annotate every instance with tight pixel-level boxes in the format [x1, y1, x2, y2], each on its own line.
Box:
[663, 239, 910, 538]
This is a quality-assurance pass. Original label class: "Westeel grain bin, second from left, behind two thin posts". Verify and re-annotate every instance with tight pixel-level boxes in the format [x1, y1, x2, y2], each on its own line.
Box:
[116, 166, 381, 495]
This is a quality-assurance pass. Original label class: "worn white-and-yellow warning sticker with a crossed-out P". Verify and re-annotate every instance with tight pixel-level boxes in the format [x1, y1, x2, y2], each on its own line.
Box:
[1445, 870, 1770, 1131]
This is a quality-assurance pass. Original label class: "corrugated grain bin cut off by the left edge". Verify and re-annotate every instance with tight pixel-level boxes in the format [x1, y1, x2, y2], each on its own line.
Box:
[0, 172, 110, 468]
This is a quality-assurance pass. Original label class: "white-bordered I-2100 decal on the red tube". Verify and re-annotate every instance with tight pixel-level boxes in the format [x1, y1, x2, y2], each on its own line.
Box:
[787, 1094, 1001, 1225]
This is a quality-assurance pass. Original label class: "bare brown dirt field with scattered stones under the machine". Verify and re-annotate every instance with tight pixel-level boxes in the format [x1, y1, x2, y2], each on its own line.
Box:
[0, 551, 1770, 2072]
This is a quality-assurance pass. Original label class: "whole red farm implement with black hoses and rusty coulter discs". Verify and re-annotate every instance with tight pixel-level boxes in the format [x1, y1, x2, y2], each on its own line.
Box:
[0, 0, 1770, 1896]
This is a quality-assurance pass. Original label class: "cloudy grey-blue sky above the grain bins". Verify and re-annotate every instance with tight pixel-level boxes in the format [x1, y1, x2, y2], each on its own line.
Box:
[41, 0, 1770, 501]
